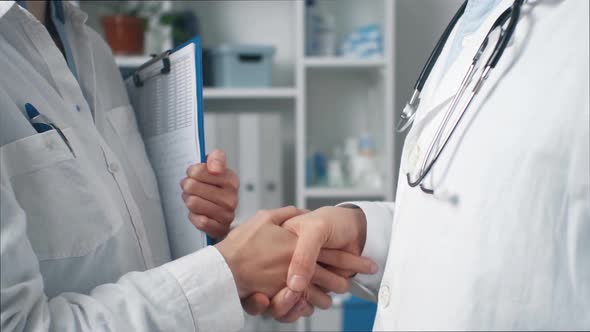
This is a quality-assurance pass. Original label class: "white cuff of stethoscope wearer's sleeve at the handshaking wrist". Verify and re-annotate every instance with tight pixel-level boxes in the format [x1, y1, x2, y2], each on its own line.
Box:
[339, 202, 395, 301]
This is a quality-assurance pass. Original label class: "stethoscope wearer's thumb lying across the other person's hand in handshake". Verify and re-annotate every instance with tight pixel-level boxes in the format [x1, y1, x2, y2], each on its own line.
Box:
[287, 220, 328, 292]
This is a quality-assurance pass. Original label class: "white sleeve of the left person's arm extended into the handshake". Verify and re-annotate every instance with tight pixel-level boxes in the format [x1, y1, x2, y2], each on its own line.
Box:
[0, 175, 243, 332]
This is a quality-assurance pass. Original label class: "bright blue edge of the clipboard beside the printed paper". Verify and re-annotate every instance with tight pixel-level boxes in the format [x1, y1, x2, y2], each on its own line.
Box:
[172, 37, 216, 246]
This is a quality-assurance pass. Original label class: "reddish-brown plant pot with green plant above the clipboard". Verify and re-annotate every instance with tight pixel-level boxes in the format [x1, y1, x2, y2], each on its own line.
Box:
[101, 1, 160, 55]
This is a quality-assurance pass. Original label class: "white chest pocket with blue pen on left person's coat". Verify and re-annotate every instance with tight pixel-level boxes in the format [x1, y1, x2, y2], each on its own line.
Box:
[0, 128, 121, 260]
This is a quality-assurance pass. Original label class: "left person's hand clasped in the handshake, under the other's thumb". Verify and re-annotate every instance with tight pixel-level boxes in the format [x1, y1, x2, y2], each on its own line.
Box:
[215, 207, 366, 312]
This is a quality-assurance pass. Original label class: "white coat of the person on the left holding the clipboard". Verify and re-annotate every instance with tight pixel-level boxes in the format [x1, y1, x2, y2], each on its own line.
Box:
[0, 1, 243, 332]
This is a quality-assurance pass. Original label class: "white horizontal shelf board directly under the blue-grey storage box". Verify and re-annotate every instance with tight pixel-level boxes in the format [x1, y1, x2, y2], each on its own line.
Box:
[203, 88, 297, 99]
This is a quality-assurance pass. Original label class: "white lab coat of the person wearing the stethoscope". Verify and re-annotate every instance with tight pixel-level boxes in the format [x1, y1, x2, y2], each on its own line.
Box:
[355, 0, 590, 331]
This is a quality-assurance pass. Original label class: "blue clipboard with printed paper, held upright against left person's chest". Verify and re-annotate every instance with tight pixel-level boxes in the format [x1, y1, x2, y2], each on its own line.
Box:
[125, 38, 211, 258]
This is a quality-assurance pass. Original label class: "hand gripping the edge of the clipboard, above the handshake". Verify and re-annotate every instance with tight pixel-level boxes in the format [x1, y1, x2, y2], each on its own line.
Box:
[180, 150, 240, 238]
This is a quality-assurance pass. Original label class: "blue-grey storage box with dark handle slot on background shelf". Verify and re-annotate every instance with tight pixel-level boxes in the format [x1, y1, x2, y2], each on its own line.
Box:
[207, 45, 275, 87]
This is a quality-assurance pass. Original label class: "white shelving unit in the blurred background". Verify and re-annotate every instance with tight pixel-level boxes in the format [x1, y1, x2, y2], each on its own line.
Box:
[107, 0, 397, 213]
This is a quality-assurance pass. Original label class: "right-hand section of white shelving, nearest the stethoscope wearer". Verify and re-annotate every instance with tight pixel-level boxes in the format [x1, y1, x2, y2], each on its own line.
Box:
[295, 0, 396, 207]
